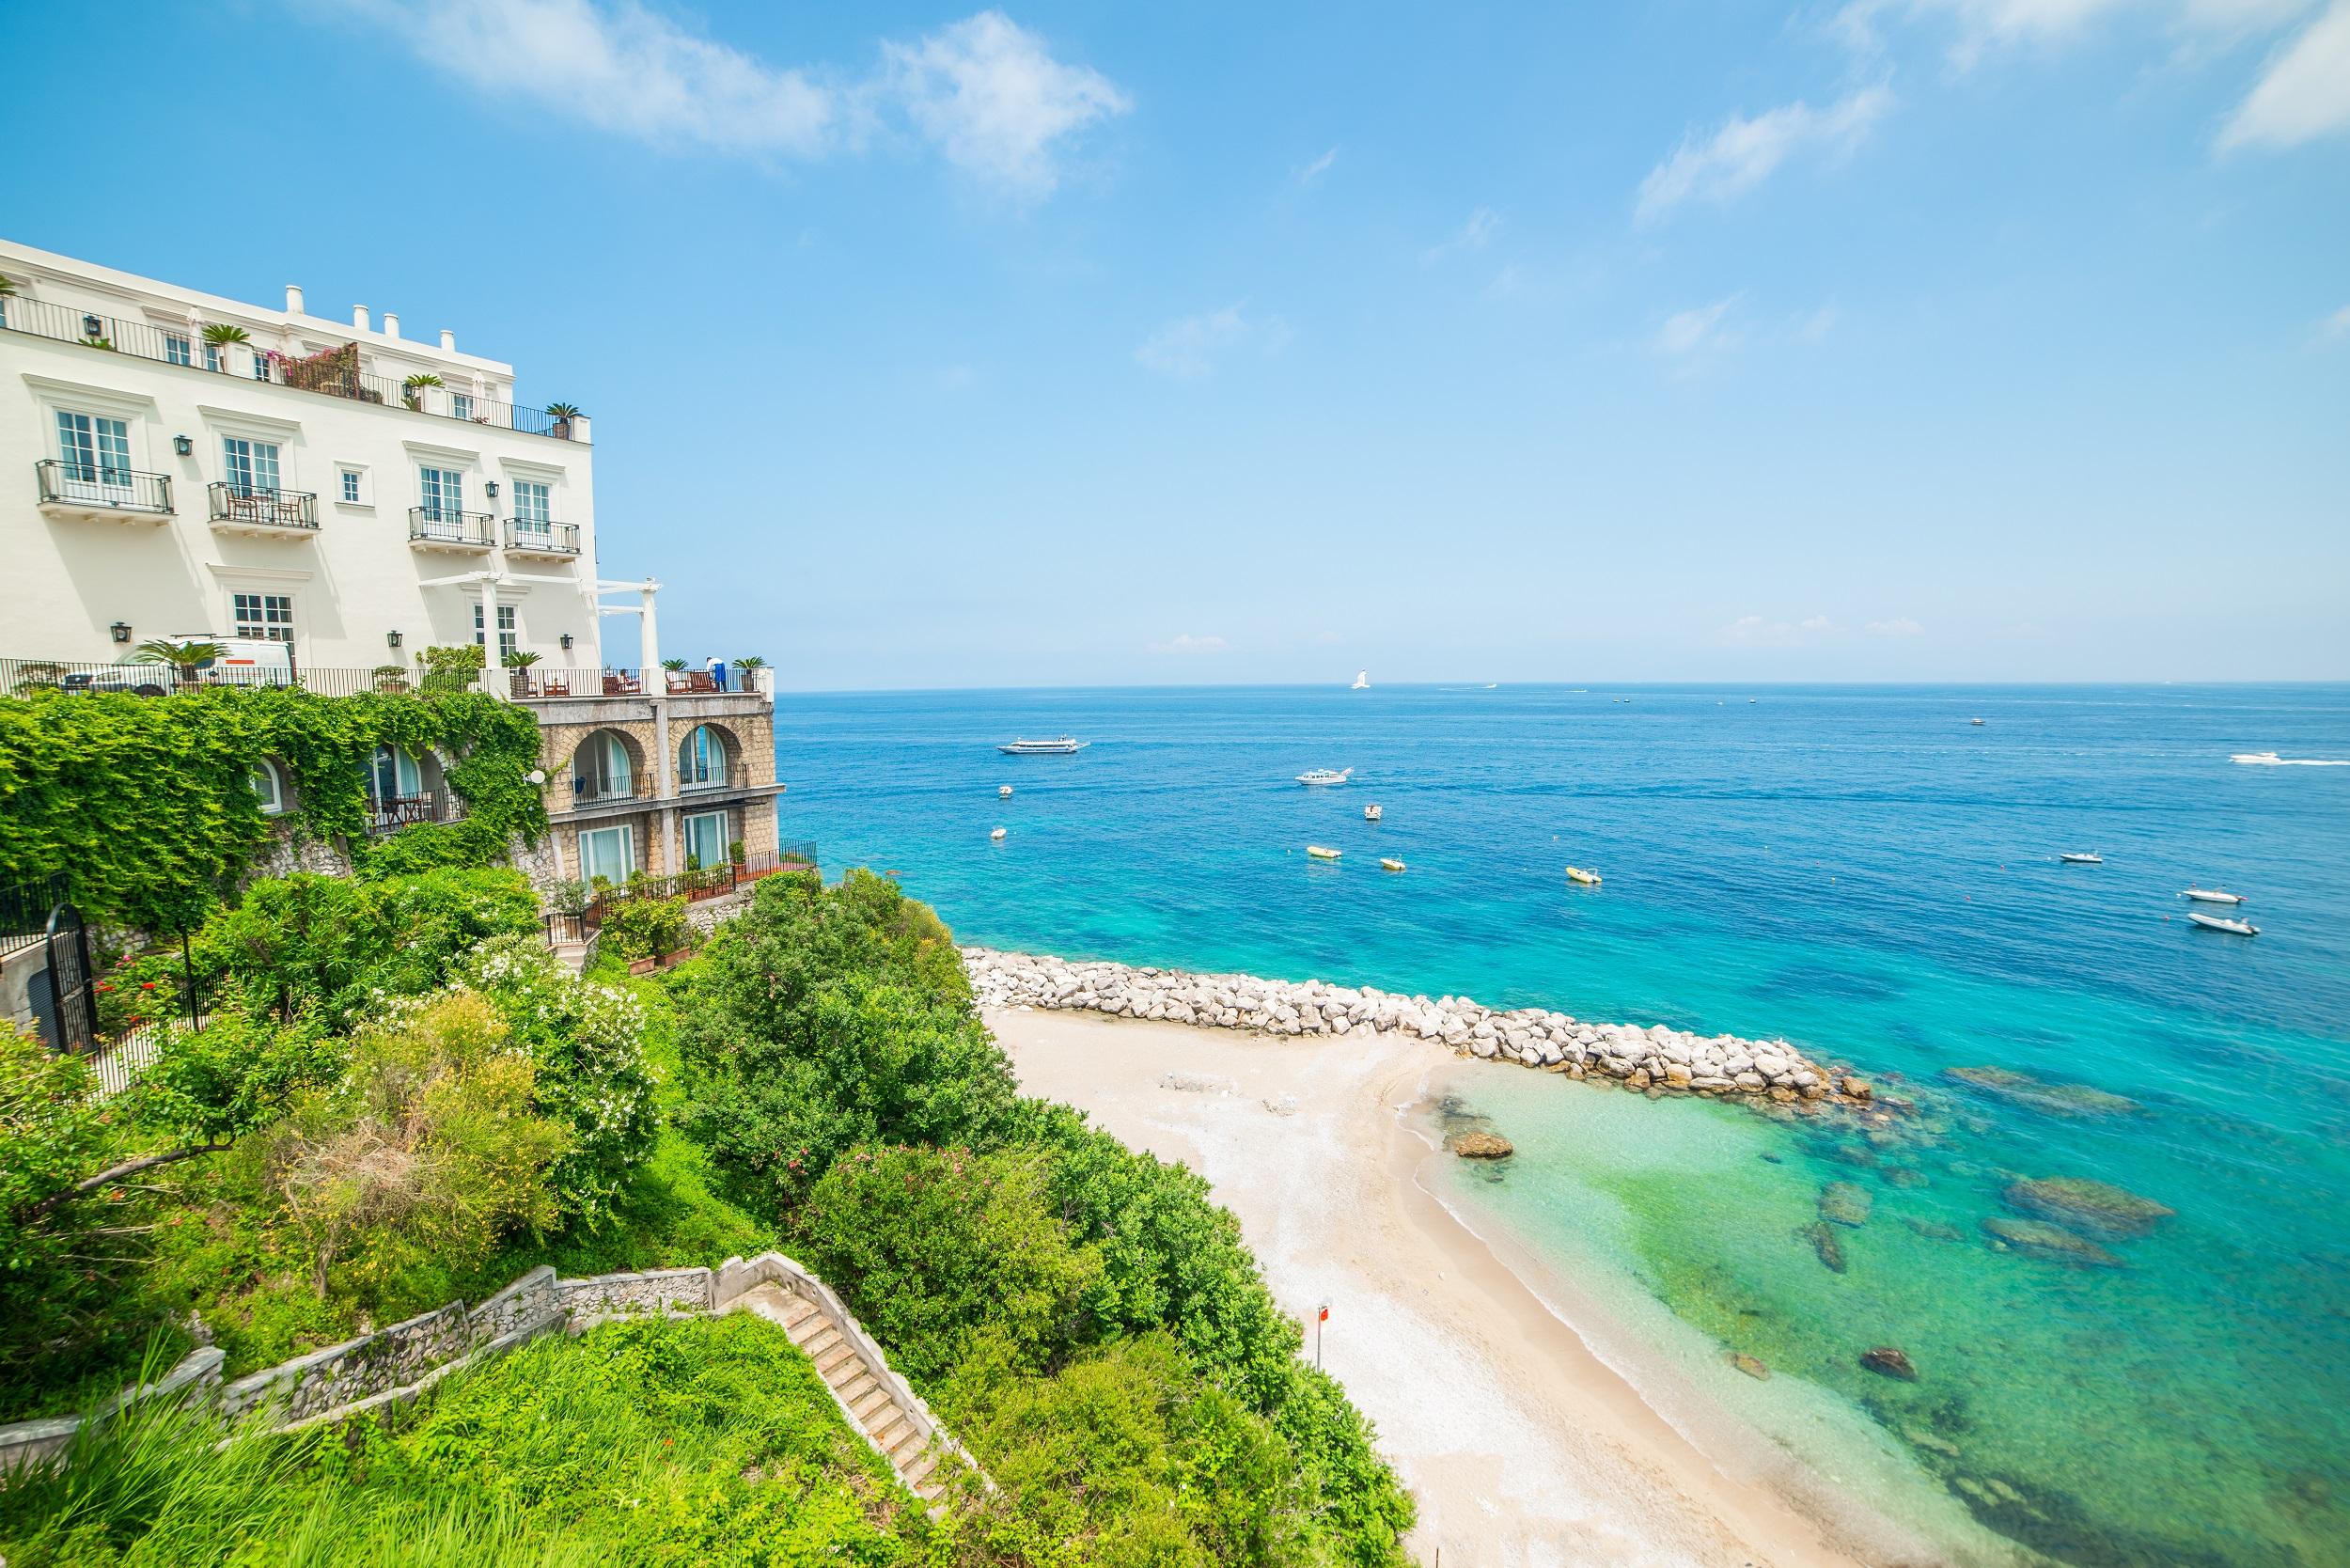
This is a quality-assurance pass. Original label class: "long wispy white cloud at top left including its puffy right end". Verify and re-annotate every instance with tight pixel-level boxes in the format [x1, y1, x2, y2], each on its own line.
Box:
[318, 0, 1128, 197]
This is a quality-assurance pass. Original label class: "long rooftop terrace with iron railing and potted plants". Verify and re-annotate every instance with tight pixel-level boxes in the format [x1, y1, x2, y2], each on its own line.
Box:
[0, 296, 588, 442]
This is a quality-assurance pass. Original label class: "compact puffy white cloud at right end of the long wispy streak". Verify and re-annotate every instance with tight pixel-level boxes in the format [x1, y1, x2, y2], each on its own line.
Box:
[882, 12, 1133, 196]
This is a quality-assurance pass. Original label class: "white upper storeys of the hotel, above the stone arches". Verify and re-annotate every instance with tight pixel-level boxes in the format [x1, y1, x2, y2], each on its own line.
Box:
[0, 240, 606, 677]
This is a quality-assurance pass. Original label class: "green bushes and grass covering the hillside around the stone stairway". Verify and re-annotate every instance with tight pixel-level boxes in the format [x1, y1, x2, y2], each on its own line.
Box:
[0, 870, 1413, 1568]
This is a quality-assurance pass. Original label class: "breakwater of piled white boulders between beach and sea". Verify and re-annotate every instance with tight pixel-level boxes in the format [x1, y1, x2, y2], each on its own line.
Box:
[964, 948, 1871, 1105]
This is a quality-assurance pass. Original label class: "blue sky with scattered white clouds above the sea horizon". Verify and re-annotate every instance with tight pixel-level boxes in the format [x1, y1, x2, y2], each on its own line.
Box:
[0, 0, 2350, 689]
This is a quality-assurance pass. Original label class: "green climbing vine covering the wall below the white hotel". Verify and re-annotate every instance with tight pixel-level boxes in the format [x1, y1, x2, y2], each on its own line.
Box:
[0, 686, 548, 933]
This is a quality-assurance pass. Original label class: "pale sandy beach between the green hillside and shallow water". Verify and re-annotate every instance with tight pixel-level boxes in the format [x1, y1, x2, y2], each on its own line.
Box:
[987, 1009, 1983, 1568]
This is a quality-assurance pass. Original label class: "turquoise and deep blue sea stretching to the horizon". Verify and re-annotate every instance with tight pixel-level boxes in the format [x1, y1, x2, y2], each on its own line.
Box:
[776, 686, 2350, 1568]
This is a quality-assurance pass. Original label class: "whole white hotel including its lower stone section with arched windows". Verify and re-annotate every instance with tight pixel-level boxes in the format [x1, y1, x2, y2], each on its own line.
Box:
[0, 240, 783, 907]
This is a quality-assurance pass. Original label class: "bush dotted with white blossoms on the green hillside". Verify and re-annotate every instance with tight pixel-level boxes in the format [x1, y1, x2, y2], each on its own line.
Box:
[456, 935, 661, 1230]
